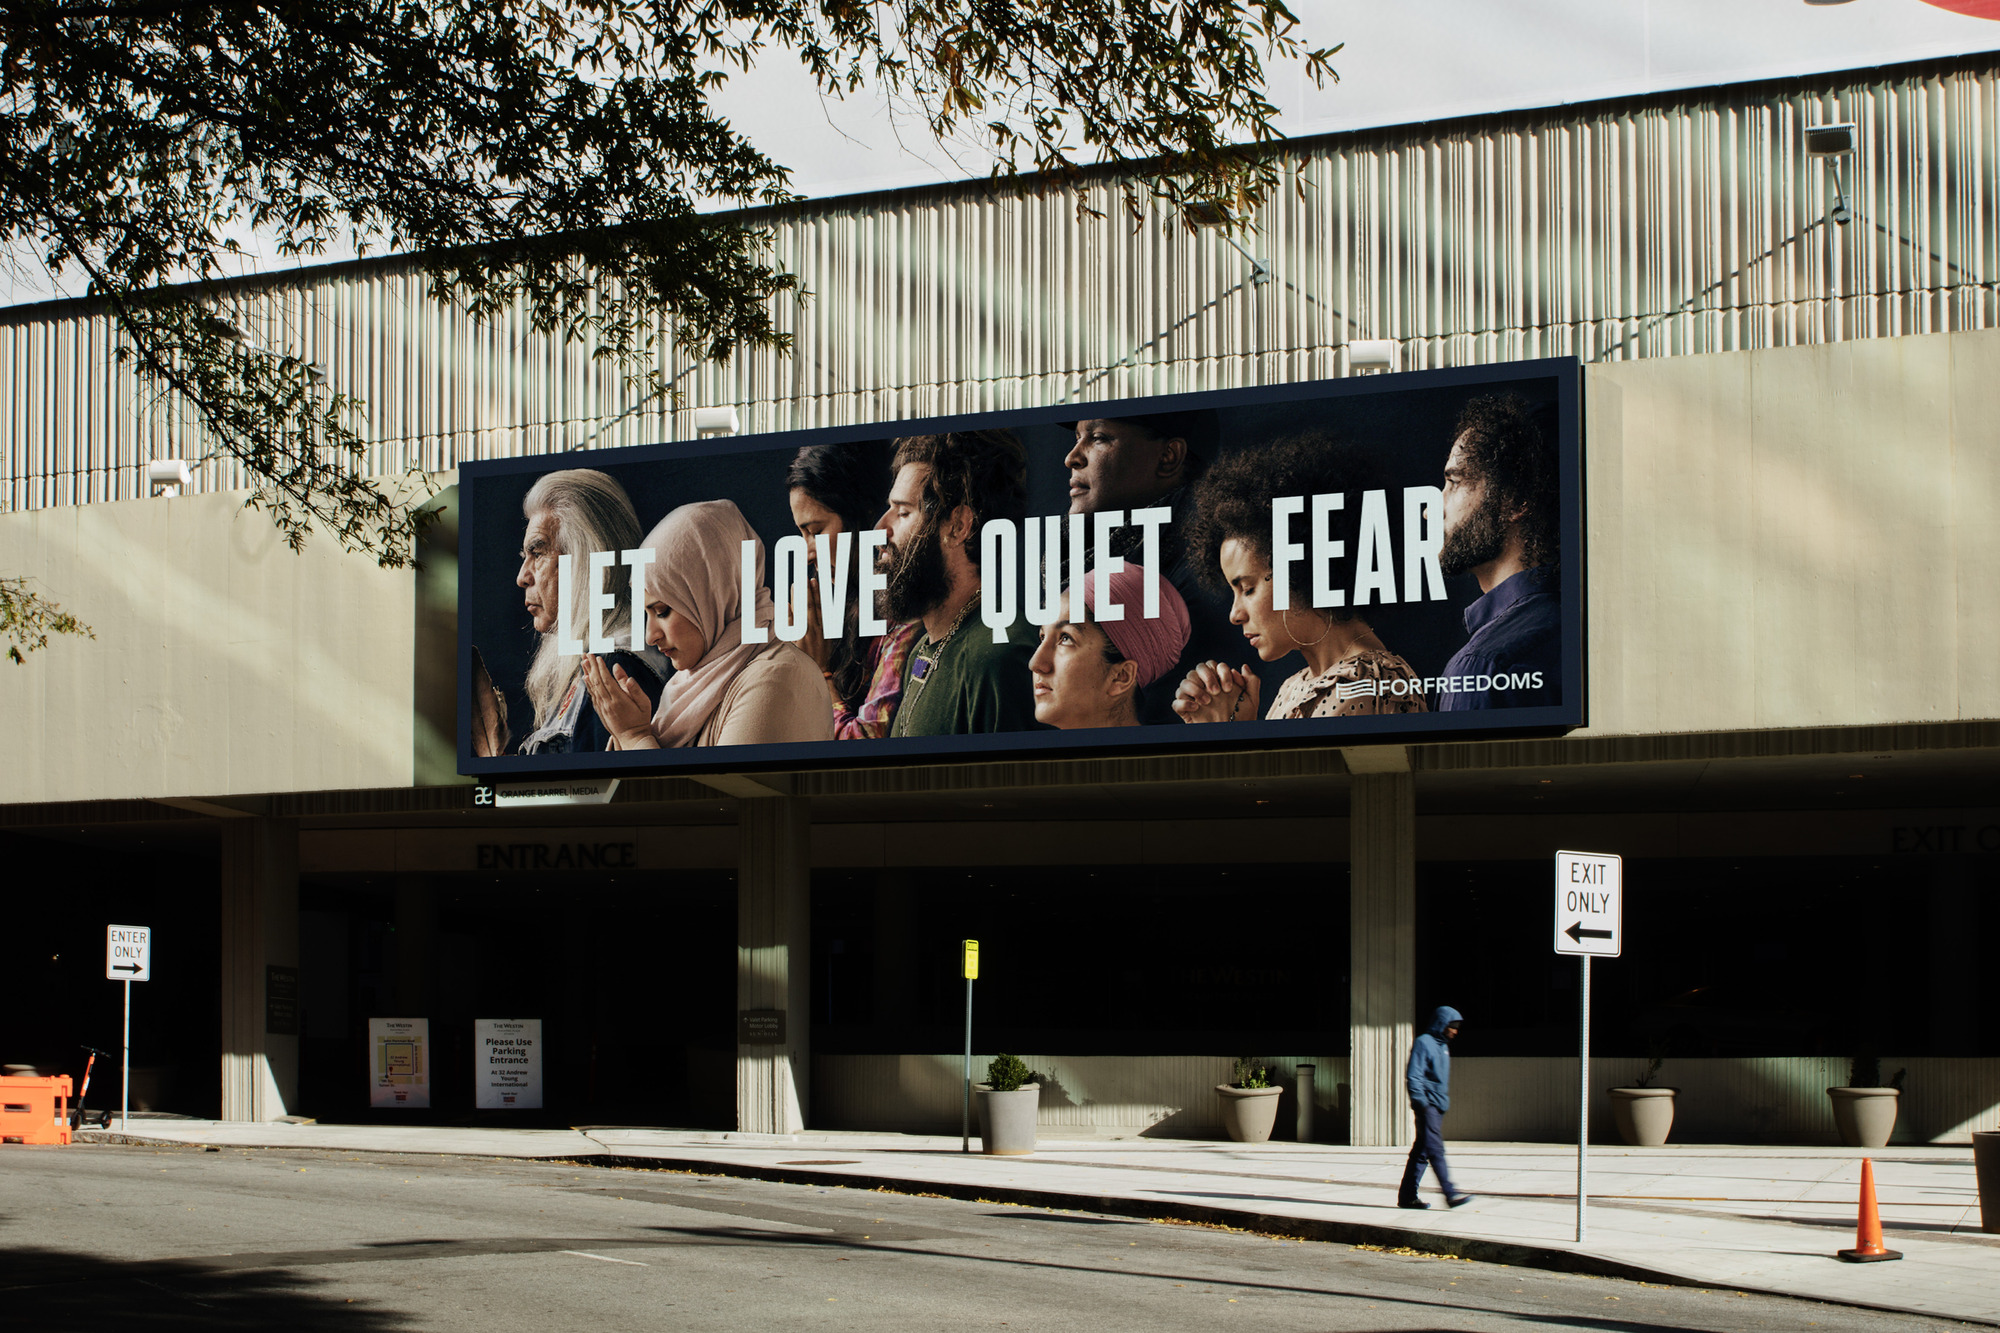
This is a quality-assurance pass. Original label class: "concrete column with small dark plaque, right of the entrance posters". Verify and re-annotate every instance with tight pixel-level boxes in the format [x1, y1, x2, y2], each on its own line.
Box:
[736, 797, 812, 1135]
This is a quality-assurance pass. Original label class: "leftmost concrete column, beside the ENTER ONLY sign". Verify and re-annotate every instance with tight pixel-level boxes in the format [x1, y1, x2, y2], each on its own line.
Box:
[222, 819, 298, 1121]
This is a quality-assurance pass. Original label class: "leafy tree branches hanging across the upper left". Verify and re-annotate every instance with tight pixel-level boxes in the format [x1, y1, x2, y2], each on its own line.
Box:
[0, 0, 1338, 604]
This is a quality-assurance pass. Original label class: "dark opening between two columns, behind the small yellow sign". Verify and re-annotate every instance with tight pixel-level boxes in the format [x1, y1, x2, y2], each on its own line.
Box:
[812, 865, 1348, 1055]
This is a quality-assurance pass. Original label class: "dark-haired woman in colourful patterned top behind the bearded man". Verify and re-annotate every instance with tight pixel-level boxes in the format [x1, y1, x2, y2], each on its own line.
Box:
[784, 442, 918, 741]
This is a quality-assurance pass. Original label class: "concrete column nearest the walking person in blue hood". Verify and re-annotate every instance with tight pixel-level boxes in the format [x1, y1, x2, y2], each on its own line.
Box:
[1348, 773, 1416, 1147]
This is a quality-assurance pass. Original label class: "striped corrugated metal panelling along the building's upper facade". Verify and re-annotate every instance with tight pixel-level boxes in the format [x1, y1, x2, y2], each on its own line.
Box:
[0, 58, 2000, 508]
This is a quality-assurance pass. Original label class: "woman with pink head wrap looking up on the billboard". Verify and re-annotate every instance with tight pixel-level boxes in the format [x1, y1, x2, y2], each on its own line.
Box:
[1028, 564, 1188, 731]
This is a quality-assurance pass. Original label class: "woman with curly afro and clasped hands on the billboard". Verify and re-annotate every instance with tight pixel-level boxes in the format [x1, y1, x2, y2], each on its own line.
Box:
[1174, 430, 1426, 723]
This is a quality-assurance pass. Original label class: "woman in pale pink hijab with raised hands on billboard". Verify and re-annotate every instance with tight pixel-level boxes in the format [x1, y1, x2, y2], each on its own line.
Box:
[584, 500, 834, 751]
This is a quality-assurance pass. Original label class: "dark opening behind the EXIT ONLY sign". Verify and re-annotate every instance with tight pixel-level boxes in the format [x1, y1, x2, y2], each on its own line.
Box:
[1416, 857, 2000, 1059]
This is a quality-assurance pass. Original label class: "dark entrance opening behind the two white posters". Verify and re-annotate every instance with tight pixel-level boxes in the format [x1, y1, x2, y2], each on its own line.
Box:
[300, 871, 736, 1129]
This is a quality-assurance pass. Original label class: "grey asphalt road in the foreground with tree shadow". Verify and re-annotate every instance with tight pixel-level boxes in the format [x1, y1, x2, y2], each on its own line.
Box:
[0, 1145, 1958, 1333]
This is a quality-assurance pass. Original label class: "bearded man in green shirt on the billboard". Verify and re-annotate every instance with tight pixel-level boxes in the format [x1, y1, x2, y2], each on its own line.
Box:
[876, 430, 1038, 737]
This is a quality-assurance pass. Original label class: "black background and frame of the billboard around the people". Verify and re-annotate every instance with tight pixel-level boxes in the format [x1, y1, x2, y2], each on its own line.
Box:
[458, 358, 1584, 779]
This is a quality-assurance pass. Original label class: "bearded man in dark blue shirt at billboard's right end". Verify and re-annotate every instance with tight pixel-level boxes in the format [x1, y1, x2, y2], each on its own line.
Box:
[1438, 394, 1562, 713]
